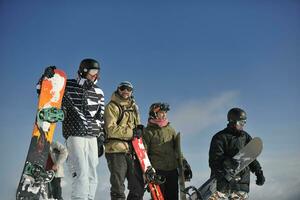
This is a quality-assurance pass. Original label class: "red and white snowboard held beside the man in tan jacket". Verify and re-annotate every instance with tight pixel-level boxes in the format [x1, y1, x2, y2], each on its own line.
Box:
[132, 137, 164, 200]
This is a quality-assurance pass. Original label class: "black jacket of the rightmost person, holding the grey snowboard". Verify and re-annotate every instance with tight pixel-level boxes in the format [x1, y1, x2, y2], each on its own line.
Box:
[209, 126, 261, 192]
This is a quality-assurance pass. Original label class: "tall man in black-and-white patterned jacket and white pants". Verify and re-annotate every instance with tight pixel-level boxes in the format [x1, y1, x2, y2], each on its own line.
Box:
[42, 58, 105, 200]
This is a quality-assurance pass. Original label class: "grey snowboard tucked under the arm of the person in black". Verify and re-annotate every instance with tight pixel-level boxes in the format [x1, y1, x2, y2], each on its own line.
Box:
[186, 137, 263, 200]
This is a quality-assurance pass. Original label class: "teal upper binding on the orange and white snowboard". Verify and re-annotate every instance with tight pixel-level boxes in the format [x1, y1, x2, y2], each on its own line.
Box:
[37, 107, 64, 123]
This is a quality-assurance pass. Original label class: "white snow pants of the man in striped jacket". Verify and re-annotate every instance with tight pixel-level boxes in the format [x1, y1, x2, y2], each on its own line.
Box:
[67, 136, 99, 200]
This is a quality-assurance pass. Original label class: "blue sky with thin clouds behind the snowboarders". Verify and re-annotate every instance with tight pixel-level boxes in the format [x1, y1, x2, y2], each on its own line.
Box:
[0, 0, 300, 200]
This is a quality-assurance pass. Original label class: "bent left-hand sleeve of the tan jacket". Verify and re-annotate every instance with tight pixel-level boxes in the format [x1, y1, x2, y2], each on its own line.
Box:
[104, 103, 133, 140]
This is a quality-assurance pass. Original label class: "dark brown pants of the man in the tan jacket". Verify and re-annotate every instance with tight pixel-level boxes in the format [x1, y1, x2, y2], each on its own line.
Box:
[105, 153, 144, 200]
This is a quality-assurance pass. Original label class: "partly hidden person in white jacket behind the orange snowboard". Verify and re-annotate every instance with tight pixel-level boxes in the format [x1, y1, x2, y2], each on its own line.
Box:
[46, 141, 68, 200]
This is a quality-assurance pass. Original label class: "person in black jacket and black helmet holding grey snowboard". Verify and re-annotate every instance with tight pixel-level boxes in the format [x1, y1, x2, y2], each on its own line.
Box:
[209, 108, 265, 200]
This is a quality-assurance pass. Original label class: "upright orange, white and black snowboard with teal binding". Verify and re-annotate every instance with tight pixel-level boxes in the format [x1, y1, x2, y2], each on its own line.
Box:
[16, 69, 66, 200]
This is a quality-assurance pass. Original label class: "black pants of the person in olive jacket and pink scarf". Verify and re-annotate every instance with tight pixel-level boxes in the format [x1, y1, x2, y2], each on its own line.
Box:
[156, 169, 178, 200]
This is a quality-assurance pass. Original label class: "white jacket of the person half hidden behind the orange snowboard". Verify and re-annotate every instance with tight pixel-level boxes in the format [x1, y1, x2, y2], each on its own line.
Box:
[49, 141, 68, 177]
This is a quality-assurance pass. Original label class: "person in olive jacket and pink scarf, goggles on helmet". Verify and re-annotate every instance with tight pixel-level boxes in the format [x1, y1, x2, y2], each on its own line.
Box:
[143, 102, 192, 200]
